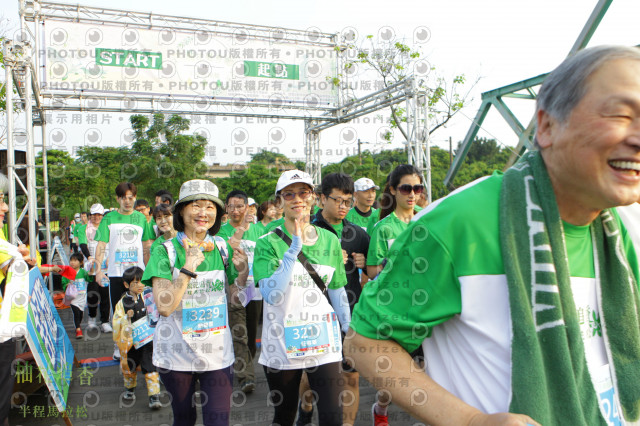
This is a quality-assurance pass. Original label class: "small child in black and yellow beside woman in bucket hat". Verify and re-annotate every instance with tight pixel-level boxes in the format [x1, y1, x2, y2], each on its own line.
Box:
[113, 266, 162, 410]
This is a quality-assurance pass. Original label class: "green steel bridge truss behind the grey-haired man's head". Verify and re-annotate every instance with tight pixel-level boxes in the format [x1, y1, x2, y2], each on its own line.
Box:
[444, 0, 613, 187]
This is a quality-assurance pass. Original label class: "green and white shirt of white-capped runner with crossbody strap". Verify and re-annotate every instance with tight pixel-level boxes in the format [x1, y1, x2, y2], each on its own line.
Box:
[254, 226, 347, 370]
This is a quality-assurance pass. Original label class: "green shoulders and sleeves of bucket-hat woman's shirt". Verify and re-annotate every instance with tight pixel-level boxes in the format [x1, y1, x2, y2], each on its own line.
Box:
[142, 238, 238, 287]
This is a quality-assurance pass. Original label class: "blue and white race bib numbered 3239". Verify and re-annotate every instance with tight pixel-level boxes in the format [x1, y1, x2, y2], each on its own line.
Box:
[182, 295, 227, 338]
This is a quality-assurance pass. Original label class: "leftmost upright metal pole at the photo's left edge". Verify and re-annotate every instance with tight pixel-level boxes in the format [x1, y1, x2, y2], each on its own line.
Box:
[3, 40, 17, 244]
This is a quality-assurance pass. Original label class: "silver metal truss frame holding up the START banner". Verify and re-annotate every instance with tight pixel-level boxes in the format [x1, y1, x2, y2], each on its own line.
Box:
[3, 0, 431, 270]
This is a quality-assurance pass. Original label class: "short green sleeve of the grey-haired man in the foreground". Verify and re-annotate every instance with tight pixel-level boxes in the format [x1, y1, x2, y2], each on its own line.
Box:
[351, 216, 462, 352]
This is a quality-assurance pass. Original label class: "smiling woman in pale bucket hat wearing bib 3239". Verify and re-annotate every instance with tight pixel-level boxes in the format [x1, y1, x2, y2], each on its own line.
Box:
[142, 179, 248, 426]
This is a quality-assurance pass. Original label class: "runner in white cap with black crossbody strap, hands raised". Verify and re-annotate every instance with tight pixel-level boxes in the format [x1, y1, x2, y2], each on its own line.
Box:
[254, 170, 351, 426]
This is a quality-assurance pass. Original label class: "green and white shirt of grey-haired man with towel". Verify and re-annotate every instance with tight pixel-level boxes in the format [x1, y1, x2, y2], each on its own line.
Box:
[351, 175, 638, 421]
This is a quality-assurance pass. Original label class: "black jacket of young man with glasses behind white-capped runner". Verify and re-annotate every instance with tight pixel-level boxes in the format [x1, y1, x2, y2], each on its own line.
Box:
[311, 210, 369, 312]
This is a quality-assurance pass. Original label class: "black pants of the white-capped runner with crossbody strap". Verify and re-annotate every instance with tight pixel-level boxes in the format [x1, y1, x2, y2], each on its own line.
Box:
[263, 362, 344, 426]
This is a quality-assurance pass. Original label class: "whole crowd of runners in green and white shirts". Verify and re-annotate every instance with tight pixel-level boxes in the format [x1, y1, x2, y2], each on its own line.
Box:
[0, 46, 640, 426]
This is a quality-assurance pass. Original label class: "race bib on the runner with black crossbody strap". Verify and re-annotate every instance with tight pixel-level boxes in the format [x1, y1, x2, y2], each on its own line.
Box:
[284, 313, 341, 358]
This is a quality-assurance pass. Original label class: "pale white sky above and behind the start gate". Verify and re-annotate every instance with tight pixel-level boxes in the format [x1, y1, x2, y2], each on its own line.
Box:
[0, 0, 640, 164]
